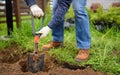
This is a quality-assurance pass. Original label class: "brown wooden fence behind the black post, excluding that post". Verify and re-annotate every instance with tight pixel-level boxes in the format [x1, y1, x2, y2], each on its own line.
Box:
[0, 0, 48, 27]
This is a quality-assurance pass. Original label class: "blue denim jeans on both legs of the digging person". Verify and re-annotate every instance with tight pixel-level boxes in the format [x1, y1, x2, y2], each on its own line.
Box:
[52, 0, 91, 49]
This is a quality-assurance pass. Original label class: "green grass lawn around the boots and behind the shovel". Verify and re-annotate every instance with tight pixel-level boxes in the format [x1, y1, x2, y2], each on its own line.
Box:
[0, 10, 120, 75]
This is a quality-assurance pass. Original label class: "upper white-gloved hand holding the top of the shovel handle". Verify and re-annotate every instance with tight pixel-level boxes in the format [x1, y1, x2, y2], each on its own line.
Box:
[30, 4, 44, 17]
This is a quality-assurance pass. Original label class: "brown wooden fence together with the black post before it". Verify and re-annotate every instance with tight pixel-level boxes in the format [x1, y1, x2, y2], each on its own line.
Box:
[0, 0, 48, 35]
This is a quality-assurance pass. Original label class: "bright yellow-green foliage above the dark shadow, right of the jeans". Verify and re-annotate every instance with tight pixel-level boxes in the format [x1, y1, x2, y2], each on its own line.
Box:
[88, 7, 120, 30]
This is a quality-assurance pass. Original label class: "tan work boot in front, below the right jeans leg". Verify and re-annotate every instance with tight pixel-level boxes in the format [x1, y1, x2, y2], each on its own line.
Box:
[75, 49, 90, 62]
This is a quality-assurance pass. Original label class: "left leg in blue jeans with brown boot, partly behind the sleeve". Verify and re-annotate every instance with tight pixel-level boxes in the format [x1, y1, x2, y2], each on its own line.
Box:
[42, 0, 64, 50]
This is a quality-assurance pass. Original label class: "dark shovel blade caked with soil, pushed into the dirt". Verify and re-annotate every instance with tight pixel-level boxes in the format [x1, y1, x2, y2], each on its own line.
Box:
[28, 53, 44, 73]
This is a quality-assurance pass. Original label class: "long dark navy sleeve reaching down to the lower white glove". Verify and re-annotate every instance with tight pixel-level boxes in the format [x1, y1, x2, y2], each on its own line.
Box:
[48, 0, 72, 29]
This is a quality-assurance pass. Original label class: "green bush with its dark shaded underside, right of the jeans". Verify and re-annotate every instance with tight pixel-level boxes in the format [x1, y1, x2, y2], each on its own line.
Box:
[88, 7, 120, 32]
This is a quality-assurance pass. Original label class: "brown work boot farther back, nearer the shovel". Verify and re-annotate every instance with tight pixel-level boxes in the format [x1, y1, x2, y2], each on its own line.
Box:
[42, 41, 63, 50]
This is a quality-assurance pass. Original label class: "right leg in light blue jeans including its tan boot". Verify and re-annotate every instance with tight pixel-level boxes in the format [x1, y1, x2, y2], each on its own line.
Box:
[72, 0, 91, 61]
